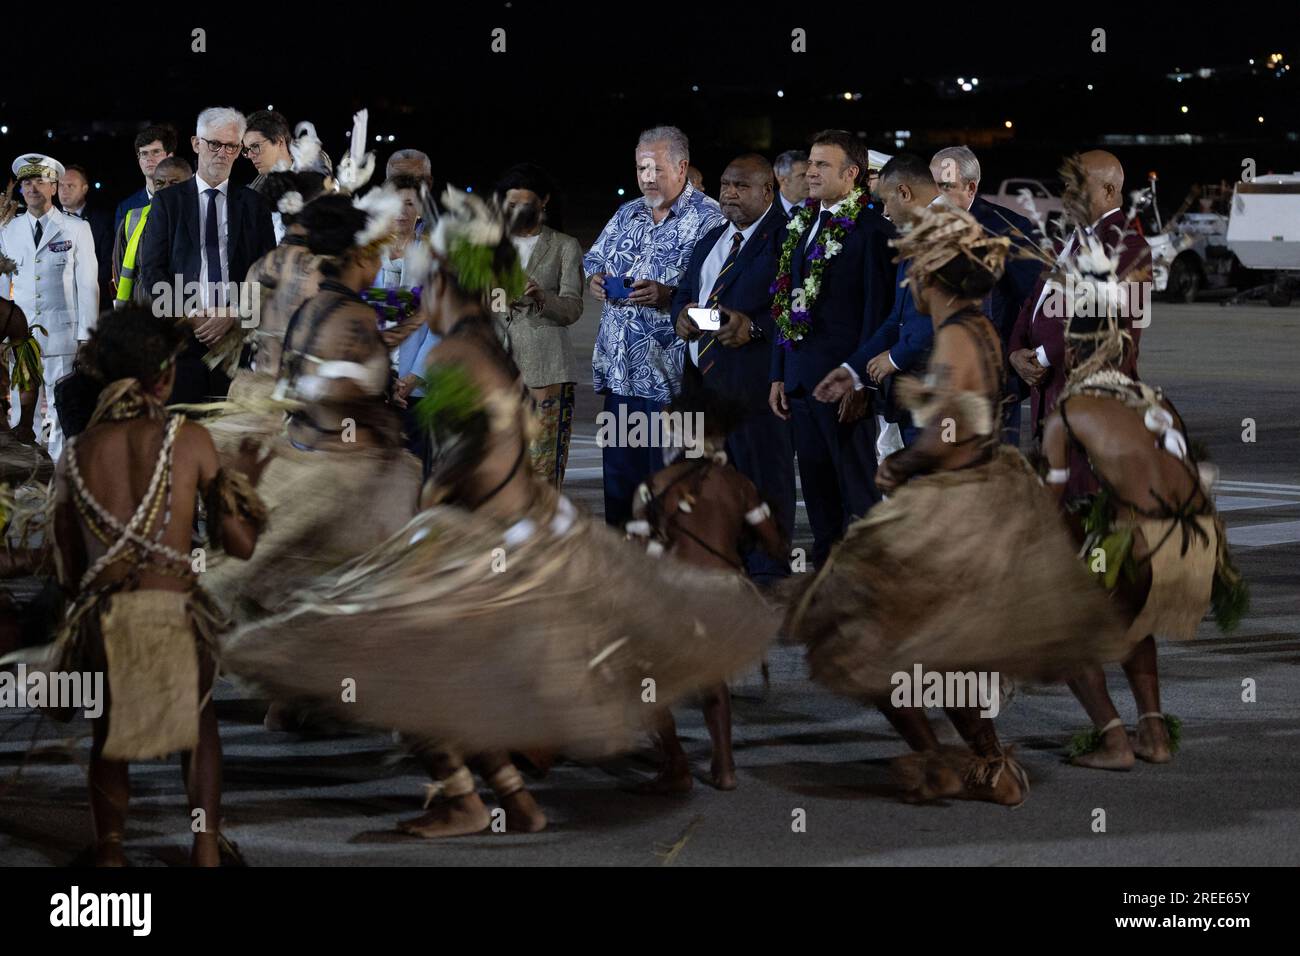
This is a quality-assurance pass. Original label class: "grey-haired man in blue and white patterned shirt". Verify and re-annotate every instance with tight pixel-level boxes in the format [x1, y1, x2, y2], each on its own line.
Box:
[582, 126, 723, 528]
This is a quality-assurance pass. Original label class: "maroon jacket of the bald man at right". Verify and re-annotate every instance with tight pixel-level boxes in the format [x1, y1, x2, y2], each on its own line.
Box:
[1008, 209, 1151, 433]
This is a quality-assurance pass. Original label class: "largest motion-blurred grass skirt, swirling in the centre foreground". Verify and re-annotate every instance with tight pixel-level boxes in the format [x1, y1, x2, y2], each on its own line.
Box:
[224, 496, 779, 756]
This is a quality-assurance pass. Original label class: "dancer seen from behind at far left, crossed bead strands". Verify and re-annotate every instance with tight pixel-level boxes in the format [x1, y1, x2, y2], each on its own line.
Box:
[47, 306, 265, 866]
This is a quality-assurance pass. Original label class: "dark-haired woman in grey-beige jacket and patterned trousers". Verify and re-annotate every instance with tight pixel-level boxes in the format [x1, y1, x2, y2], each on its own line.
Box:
[494, 164, 584, 488]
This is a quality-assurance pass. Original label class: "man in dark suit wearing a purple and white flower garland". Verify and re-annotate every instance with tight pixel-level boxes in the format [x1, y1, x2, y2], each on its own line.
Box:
[768, 130, 896, 564]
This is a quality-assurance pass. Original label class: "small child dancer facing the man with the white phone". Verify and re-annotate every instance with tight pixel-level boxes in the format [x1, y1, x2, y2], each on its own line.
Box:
[628, 376, 789, 793]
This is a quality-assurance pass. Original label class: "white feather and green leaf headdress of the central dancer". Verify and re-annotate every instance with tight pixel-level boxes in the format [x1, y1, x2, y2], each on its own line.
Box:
[406, 186, 528, 302]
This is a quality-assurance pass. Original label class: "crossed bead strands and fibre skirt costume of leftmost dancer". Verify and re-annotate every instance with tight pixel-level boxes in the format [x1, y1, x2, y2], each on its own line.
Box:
[46, 378, 265, 760]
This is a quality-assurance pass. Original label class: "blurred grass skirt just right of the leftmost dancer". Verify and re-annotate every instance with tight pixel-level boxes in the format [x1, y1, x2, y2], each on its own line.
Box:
[203, 437, 420, 622]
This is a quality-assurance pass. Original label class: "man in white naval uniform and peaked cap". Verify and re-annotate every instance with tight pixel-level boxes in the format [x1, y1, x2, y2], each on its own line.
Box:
[0, 153, 99, 460]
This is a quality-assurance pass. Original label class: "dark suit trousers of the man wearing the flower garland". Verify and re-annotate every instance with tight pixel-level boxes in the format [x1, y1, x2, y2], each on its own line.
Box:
[789, 397, 880, 564]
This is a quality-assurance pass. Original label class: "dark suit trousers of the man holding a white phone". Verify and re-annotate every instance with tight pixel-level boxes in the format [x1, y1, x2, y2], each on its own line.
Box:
[727, 407, 794, 584]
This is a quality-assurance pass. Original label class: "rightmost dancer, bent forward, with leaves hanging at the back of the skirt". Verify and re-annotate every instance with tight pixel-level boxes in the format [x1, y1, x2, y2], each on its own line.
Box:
[1044, 299, 1247, 770]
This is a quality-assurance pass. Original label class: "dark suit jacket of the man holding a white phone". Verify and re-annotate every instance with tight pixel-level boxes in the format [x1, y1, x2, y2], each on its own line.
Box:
[672, 200, 787, 411]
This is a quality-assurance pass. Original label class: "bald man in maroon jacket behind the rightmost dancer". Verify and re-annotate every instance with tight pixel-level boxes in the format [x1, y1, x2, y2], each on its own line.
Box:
[1009, 150, 1151, 437]
